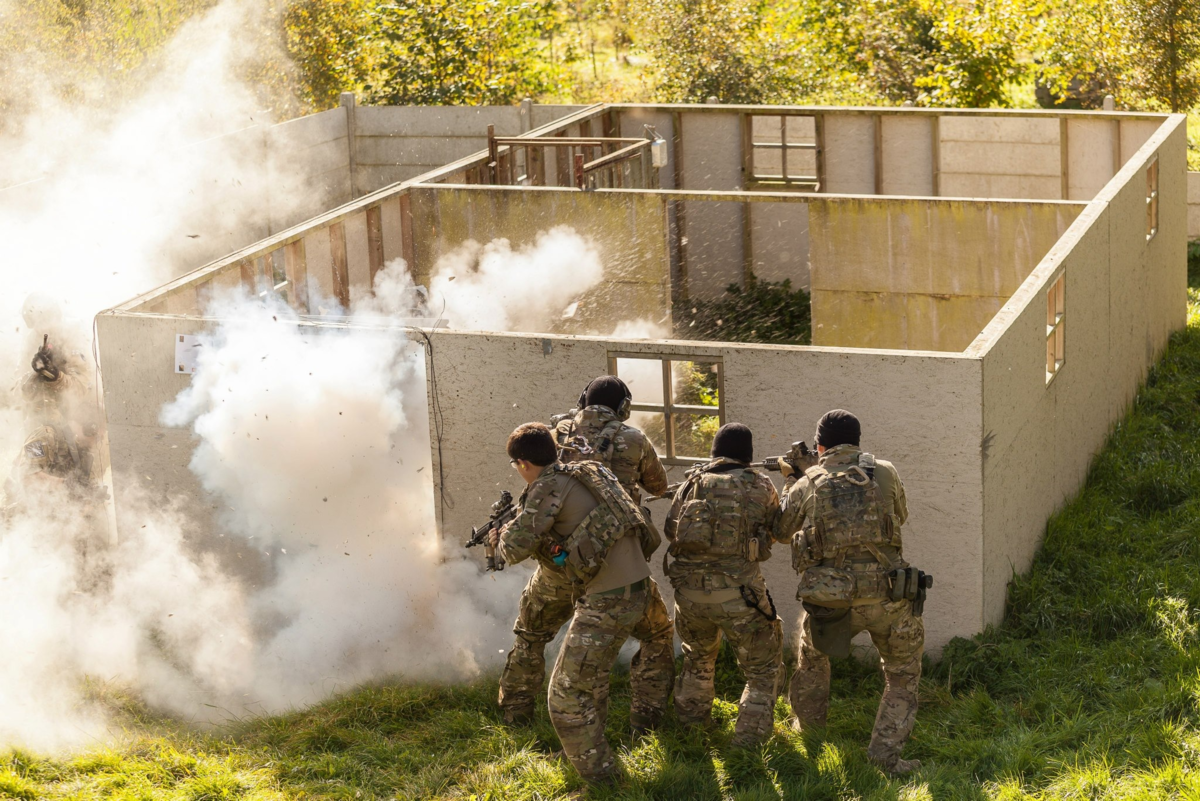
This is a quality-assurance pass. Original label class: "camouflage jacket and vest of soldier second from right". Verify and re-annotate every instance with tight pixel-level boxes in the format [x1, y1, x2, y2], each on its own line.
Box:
[666, 458, 780, 590]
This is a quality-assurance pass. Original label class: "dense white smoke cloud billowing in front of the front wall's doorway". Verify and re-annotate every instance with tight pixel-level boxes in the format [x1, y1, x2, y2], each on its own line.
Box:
[163, 284, 520, 710]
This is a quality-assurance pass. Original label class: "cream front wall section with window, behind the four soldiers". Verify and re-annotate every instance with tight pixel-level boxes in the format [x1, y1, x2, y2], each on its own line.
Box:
[427, 331, 983, 652]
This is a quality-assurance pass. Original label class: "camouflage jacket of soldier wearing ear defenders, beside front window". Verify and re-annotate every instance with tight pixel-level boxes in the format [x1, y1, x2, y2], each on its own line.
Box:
[554, 406, 667, 504]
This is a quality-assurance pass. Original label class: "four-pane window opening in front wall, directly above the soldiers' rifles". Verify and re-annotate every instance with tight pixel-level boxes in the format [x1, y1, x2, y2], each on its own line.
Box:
[608, 353, 725, 464]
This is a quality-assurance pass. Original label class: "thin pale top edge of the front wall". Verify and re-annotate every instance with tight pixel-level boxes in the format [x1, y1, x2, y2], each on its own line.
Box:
[96, 308, 982, 363]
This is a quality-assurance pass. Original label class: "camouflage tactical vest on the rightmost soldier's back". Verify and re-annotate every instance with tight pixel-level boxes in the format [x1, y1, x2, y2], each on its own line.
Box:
[792, 453, 904, 607]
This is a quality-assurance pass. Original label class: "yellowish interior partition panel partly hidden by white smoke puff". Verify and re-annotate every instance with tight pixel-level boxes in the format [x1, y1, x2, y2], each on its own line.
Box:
[409, 186, 671, 330]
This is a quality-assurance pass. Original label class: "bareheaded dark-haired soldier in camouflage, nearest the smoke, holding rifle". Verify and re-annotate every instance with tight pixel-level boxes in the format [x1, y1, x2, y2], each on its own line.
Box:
[496, 423, 674, 781]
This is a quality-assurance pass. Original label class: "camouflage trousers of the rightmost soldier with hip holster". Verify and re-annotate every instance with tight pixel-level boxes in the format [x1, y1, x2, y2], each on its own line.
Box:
[788, 601, 925, 765]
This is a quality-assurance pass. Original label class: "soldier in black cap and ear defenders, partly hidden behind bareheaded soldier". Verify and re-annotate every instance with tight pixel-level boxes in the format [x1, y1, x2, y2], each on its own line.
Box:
[499, 375, 674, 730]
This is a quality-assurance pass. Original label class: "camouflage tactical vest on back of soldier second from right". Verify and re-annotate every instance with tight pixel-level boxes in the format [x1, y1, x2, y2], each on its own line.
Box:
[666, 469, 751, 559]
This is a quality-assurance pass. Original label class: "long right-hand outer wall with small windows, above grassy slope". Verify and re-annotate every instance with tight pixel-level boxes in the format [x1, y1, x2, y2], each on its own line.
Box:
[967, 116, 1187, 622]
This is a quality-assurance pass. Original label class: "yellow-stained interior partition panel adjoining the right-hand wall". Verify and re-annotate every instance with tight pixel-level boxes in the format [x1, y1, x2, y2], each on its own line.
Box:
[811, 198, 1084, 353]
